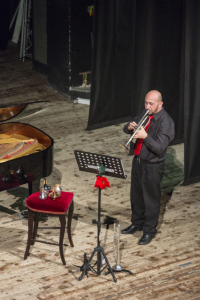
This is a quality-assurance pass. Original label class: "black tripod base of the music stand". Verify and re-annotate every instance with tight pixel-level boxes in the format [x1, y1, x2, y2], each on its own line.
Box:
[78, 247, 117, 282]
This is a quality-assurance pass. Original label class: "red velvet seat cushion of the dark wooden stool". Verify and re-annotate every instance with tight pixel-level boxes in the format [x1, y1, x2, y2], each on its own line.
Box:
[26, 192, 74, 214]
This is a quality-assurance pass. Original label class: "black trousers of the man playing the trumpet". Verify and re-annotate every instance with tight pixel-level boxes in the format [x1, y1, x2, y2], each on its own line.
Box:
[131, 157, 165, 235]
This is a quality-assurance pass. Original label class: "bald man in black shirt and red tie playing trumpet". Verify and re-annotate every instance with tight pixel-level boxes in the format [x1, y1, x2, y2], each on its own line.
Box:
[122, 90, 175, 245]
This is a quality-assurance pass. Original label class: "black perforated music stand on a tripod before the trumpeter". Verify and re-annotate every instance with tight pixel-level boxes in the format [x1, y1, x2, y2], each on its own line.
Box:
[74, 150, 127, 282]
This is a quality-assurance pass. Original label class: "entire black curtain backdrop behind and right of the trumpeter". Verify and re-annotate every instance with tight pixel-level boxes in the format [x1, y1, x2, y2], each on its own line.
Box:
[87, 0, 200, 184]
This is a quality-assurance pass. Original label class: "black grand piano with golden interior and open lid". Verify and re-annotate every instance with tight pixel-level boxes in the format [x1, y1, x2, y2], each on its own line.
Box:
[0, 101, 54, 195]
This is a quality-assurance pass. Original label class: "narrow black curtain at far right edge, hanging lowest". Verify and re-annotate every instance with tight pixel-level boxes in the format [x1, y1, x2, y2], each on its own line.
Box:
[184, 0, 200, 185]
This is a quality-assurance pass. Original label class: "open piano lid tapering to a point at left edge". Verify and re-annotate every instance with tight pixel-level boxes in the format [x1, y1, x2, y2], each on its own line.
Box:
[0, 101, 50, 123]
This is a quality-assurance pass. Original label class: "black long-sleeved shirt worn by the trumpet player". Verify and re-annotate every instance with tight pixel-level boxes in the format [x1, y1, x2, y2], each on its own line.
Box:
[124, 108, 175, 162]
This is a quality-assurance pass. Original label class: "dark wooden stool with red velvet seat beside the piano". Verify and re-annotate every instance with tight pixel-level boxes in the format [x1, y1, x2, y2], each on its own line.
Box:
[24, 192, 74, 265]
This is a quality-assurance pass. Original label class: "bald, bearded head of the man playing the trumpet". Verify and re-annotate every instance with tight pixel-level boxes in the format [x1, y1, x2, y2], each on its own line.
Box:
[145, 90, 163, 115]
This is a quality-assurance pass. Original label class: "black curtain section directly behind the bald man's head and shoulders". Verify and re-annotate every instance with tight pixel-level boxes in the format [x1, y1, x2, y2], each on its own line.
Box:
[131, 0, 184, 143]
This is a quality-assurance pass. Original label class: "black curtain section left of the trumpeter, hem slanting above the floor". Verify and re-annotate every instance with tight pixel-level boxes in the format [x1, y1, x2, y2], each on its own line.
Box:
[88, 0, 135, 129]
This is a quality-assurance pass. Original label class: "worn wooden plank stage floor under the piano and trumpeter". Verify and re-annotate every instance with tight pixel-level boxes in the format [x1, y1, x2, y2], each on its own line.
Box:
[0, 45, 200, 300]
